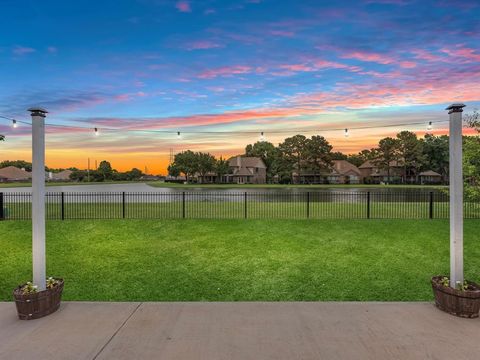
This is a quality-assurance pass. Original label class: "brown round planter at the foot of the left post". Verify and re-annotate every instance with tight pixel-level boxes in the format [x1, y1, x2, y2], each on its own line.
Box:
[13, 279, 63, 320]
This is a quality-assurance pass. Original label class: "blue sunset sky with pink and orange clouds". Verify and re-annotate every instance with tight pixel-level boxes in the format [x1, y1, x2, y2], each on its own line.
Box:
[0, 0, 480, 173]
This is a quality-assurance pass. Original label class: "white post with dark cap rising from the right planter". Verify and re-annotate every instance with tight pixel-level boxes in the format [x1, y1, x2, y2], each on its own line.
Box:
[446, 104, 465, 288]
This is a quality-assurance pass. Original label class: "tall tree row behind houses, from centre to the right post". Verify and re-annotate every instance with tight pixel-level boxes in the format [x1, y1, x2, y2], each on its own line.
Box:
[245, 131, 456, 183]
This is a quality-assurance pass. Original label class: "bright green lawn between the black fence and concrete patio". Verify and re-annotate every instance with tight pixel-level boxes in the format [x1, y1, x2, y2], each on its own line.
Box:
[0, 220, 480, 301]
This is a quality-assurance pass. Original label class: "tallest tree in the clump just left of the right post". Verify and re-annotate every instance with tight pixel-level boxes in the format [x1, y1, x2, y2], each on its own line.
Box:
[397, 131, 425, 183]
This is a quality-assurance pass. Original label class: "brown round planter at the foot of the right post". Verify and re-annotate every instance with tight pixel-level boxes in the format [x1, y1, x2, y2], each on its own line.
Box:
[432, 276, 480, 318]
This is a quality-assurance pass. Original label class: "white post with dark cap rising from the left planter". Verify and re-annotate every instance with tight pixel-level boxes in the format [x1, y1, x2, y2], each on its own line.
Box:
[28, 107, 47, 291]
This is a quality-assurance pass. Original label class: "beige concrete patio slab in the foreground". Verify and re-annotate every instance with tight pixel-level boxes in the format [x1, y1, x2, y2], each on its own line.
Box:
[0, 302, 480, 360]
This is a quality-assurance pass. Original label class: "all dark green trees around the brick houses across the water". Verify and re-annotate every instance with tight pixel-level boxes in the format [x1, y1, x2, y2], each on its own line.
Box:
[168, 131, 464, 183]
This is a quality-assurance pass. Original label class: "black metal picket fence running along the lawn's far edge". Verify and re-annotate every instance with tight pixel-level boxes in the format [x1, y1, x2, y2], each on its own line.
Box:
[0, 191, 480, 220]
